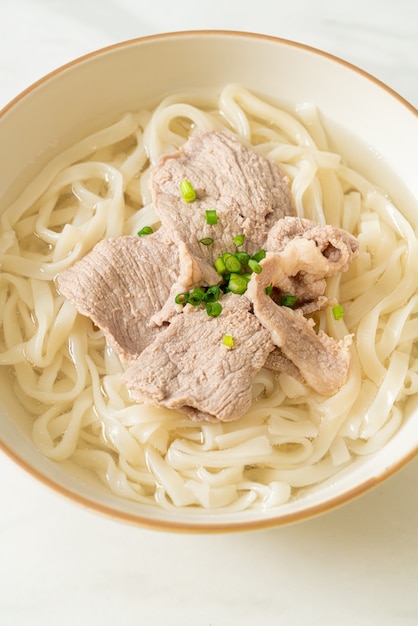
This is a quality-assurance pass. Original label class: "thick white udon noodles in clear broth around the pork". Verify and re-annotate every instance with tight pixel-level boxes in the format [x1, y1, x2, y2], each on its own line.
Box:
[0, 85, 418, 511]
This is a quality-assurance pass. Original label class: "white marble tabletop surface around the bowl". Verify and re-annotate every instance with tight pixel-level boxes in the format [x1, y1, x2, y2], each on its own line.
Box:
[0, 0, 418, 626]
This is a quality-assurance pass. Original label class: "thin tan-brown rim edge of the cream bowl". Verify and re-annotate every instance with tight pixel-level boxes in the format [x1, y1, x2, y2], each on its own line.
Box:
[0, 29, 418, 533]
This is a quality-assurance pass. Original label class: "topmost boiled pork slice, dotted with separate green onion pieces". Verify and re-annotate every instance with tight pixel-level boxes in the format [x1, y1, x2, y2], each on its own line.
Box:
[151, 131, 294, 263]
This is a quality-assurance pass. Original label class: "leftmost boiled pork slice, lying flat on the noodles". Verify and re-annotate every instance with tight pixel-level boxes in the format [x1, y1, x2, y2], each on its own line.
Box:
[56, 229, 179, 362]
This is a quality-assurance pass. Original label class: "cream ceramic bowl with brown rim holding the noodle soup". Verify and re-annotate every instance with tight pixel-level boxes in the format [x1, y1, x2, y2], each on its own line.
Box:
[0, 31, 418, 531]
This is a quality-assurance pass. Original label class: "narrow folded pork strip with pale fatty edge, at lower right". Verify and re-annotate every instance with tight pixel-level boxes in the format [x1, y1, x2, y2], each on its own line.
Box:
[246, 254, 352, 396]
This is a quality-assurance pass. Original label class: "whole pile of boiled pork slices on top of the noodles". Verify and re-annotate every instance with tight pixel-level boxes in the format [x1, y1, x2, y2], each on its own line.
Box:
[57, 131, 358, 421]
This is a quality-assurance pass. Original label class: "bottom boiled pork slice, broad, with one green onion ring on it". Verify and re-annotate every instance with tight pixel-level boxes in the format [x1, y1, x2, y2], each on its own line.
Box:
[123, 294, 273, 422]
